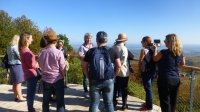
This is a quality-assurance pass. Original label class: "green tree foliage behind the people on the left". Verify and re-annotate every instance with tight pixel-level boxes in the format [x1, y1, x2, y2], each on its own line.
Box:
[0, 10, 72, 54]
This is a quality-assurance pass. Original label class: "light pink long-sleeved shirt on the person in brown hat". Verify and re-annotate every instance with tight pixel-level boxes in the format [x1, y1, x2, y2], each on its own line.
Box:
[38, 46, 65, 83]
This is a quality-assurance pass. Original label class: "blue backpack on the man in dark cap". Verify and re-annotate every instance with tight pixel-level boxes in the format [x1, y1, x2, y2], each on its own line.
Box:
[89, 47, 115, 80]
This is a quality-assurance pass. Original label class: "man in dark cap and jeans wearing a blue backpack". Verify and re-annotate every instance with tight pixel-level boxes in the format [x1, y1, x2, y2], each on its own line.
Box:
[83, 31, 121, 112]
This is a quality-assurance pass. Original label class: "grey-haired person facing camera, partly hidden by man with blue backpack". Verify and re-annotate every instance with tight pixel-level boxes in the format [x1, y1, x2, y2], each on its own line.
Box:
[78, 33, 93, 98]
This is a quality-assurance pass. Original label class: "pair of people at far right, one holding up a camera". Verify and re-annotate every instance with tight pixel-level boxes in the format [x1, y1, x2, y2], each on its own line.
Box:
[139, 34, 185, 112]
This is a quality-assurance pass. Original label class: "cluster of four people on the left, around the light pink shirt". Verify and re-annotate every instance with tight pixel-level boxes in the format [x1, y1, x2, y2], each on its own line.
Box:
[7, 28, 69, 112]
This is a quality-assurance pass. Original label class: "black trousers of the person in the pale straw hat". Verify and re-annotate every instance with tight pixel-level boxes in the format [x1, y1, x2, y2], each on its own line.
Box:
[113, 76, 129, 105]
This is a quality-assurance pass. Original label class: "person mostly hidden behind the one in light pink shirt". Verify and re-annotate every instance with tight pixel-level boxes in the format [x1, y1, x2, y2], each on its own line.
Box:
[57, 40, 69, 88]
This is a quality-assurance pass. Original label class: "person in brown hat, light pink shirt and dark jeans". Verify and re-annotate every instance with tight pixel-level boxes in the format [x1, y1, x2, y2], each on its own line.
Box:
[38, 28, 66, 112]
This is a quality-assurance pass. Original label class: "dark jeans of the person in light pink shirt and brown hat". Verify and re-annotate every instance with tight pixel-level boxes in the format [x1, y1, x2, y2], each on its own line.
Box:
[42, 79, 65, 112]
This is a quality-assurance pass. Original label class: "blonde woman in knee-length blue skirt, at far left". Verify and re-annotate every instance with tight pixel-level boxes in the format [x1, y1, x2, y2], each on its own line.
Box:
[7, 35, 25, 102]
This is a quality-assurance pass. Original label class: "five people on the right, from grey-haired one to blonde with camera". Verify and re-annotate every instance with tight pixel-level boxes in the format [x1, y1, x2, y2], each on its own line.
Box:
[79, 31, 185, 112]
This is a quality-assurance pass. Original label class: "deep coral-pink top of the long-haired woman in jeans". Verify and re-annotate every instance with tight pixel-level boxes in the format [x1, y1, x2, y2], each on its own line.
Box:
[20, 48, 37, 80]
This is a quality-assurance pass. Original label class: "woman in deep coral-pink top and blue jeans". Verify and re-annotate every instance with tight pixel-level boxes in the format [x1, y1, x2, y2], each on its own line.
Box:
[19, 32, 38, 112]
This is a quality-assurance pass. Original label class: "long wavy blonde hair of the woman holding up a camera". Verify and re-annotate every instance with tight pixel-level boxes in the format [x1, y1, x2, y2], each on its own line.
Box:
[165, 34, 182, 56]
